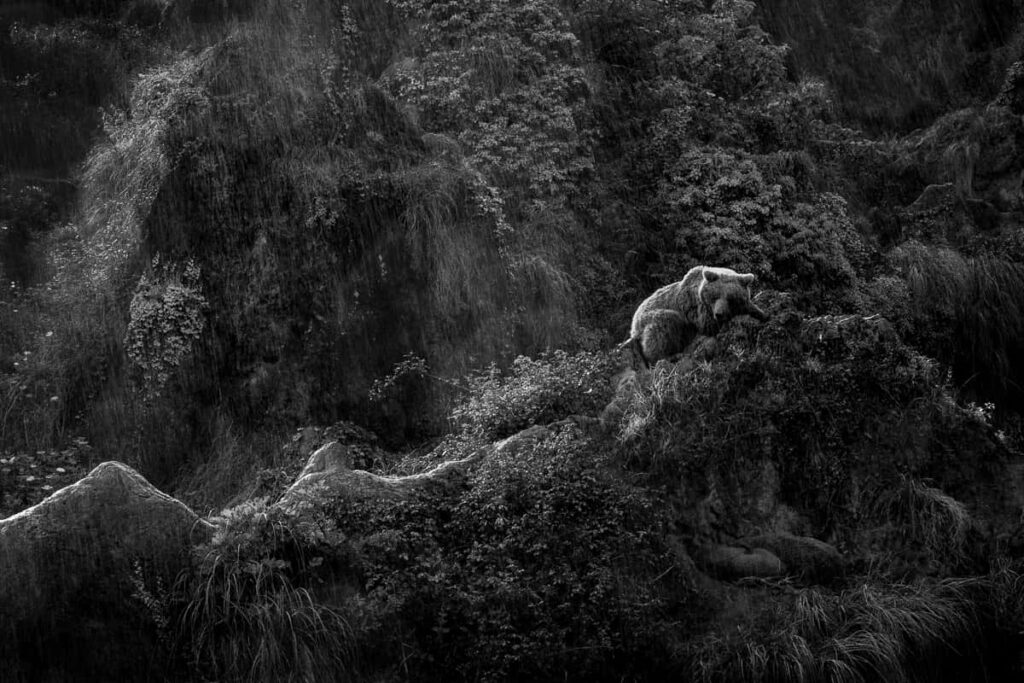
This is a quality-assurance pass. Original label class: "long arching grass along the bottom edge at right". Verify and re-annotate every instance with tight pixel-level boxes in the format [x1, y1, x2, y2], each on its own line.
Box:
[689, 581, 983, 683]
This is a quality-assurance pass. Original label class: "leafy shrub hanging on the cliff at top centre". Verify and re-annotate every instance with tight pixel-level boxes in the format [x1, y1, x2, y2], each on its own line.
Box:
[392, 0, 591, 201]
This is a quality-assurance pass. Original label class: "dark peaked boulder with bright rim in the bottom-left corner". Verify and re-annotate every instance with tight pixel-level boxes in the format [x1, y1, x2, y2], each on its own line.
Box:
[0, 462, 213, 680]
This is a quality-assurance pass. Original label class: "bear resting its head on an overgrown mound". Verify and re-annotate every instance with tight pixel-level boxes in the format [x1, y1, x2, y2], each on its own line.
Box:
[620, 265, 768, 368]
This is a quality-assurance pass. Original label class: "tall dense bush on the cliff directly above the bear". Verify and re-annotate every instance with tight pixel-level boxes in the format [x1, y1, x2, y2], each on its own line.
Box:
[581, 2, 867, 323]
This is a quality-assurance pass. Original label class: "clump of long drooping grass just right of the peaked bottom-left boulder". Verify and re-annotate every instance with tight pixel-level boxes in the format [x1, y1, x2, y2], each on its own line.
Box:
[176, 501, 354, 682]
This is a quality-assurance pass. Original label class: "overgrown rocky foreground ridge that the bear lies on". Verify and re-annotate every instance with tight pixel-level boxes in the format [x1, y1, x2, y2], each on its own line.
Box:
[0, 313, 1024, 683]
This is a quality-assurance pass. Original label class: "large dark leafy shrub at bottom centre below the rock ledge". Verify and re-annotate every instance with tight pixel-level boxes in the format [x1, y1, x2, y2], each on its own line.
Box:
[332, 432, 693, 680]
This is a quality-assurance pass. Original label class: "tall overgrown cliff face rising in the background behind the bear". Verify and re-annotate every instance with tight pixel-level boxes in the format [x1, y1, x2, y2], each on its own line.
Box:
[0, 0, 1019, 483]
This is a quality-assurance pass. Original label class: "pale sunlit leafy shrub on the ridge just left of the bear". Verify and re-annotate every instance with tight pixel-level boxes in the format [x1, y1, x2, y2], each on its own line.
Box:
[452, 351, 613, 440]
